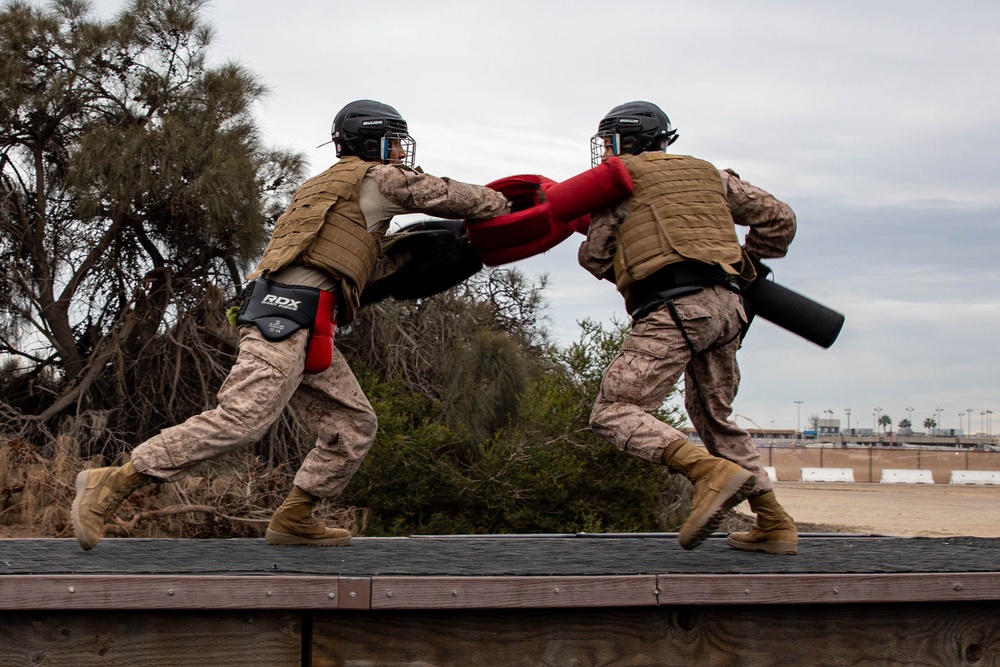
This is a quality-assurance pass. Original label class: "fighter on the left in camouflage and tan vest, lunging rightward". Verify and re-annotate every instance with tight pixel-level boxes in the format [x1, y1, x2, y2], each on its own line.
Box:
[72, 100, 508, 549]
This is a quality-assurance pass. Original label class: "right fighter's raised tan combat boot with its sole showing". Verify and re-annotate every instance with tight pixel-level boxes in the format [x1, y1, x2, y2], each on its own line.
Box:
[663, 440, 755, 549]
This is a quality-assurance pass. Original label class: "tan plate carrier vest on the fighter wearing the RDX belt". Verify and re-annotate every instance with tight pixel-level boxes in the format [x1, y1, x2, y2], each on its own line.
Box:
[249, 157, 382, 325]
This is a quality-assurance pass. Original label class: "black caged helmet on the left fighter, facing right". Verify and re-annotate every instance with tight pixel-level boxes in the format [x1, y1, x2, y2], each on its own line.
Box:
[330, 100, 416, 167]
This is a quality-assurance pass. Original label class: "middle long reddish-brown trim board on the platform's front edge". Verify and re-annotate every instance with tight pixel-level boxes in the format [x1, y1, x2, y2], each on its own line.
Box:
[371, 575, 656, 609]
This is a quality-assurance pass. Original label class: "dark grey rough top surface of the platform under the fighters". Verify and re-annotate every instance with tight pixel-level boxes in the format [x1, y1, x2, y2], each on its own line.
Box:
[0, 535, 1000, 577]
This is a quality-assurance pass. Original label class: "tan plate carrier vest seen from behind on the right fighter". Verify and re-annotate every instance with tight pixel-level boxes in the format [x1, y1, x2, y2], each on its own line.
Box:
[614, 152, 743, 303]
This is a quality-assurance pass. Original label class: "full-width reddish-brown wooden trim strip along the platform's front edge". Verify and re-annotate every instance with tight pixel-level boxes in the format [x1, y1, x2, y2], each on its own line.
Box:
[0, 572, 1000, 610]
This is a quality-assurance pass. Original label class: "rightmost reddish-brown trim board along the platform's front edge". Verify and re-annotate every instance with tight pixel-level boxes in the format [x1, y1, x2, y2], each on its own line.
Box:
[657, 572, 1000, 605]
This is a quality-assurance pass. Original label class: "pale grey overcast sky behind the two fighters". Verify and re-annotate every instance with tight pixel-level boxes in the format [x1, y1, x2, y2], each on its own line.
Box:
[84, 0, 1000, 433]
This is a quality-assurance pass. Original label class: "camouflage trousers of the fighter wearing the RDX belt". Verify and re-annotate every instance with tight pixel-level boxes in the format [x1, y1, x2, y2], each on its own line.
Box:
[132, 326, 378, 498]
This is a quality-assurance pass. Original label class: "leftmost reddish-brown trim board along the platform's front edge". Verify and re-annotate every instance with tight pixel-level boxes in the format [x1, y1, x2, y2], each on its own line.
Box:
[0, 575, 340, 610]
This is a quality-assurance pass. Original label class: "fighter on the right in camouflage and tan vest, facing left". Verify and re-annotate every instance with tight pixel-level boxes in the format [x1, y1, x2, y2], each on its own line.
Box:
[579, 102, 798, 554]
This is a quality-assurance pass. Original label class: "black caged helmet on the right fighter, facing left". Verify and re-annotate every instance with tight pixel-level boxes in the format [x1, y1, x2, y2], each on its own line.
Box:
[590, 101, 678, 166]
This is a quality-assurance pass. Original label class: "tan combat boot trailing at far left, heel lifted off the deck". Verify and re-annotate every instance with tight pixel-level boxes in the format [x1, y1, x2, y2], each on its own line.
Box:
[70, 461, 155, 550]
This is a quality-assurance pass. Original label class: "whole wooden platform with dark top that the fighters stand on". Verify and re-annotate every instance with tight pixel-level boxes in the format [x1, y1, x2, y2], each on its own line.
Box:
[0, 535, 1000, 666]
